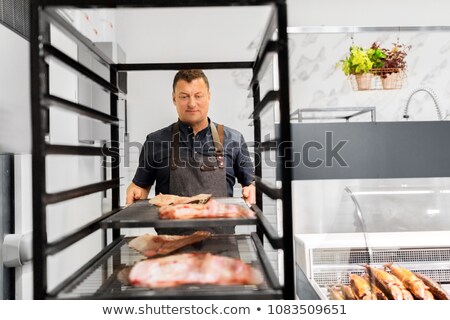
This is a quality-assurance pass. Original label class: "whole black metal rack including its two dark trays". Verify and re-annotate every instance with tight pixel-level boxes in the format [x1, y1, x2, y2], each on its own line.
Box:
[30, 0, 295, 299]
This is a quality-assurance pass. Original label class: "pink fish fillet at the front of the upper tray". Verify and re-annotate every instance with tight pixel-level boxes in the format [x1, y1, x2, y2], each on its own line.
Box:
[159, 200, 255, 220]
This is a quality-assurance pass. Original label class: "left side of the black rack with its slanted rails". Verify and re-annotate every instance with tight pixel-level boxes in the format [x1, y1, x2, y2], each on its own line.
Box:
[30, 1, 121, 299]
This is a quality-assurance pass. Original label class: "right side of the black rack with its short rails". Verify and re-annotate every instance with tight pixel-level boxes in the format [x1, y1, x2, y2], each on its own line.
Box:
[250, 2, 295, 299]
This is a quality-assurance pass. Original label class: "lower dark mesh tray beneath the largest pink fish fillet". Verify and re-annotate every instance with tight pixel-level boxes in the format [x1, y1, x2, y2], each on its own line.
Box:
[58, 236, 280, 298]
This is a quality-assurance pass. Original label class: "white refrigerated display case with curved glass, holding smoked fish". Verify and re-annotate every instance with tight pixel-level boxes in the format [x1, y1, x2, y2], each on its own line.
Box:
[295, 179, 450, 299]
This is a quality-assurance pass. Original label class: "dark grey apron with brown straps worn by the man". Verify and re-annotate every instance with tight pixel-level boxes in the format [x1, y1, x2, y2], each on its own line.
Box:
[157, 122, 234, 234]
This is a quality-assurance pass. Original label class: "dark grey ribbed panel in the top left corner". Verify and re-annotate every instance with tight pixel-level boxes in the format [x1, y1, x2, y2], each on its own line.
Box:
[0, 0, 30, 40]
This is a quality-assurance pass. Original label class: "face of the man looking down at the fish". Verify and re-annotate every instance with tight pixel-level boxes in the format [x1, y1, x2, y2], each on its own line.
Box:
[172, 78, 210, 126]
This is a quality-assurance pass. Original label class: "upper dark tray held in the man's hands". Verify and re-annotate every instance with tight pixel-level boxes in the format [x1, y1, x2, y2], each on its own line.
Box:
[100, 197, 257, 229]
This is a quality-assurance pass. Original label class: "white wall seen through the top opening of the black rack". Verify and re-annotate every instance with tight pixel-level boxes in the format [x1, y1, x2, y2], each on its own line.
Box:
[116, 6, 270, 63]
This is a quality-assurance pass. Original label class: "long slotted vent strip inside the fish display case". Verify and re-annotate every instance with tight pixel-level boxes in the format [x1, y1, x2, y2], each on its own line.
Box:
[312, 248, 450, 266]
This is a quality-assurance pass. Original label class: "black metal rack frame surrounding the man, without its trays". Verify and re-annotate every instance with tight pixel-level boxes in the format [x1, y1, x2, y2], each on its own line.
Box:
[30, 0, 295, 299]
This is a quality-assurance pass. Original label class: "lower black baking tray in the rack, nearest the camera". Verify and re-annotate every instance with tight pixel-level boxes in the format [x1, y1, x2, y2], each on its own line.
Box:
[53, 233, 282, 299]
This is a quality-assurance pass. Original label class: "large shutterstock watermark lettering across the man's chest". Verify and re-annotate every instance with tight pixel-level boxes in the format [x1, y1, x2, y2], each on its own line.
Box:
[102, 131, 349, 169]
